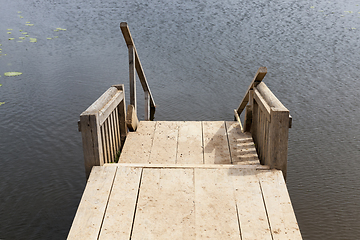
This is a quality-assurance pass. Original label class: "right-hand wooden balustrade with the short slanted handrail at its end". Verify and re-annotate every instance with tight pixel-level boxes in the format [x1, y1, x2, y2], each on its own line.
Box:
[235, 67, 292, 179]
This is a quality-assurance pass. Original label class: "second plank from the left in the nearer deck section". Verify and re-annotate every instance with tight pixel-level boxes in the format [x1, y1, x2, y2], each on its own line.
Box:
[99, 166, 142, 240]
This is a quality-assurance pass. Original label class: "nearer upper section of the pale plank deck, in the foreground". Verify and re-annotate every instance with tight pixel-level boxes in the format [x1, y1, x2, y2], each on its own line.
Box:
[68, 164, 301, 240]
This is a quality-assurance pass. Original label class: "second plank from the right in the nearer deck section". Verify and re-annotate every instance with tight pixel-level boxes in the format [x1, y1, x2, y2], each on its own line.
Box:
[229, 169, 272, 240]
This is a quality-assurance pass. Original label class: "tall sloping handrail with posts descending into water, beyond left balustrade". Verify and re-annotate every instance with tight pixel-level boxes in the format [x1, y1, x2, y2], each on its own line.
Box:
[120, 22, 156, 120]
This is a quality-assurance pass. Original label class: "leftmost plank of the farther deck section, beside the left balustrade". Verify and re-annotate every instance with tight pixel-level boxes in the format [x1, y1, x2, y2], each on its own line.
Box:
[119, 121, 156, 163]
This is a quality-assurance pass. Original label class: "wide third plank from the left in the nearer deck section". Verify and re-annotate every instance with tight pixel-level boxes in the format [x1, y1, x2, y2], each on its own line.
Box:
[131, 169, 196, 239]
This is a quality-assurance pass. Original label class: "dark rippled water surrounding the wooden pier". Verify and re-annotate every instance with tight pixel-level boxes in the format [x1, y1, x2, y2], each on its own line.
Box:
[0, 0, 360, 239]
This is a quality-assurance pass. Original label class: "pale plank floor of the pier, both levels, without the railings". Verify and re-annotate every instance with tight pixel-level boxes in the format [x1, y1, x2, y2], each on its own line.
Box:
[68, 121, 301, 239]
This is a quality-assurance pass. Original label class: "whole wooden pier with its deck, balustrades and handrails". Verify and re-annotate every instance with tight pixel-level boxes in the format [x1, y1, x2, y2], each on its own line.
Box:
[68, 23, 302, 239]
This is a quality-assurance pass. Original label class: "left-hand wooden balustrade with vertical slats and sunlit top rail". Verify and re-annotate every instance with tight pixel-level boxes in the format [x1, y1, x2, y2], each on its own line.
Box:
[79, 84, 127, 178]
